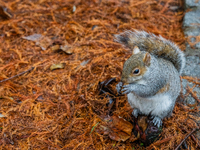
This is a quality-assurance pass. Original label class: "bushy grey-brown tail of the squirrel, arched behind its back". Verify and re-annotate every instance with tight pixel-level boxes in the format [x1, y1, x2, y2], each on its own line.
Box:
[115, 30, 185, 74]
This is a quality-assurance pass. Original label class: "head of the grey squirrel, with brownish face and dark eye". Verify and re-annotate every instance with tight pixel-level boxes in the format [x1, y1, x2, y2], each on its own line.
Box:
[121, 46, 151, 84]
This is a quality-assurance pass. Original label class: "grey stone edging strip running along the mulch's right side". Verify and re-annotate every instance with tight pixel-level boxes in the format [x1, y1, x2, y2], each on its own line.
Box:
[182, 0, 200, 139]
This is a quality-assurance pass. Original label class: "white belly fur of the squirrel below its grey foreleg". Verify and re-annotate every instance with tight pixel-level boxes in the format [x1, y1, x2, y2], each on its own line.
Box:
[127, 93, 172, 118]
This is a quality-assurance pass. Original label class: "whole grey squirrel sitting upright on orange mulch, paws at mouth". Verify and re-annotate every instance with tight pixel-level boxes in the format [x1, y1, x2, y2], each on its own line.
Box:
[115, 30, 185, 127]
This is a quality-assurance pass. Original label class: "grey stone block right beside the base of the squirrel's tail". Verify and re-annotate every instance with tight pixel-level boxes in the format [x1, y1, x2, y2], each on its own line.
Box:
[182, 56, 200, 78]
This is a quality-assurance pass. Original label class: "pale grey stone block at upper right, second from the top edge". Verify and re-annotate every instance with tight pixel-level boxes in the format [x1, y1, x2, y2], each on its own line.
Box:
[183, 9, 200, 27]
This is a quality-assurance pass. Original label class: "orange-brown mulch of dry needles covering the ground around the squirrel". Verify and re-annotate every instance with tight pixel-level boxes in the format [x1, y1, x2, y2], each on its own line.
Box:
[0, 0, 200, 150]
